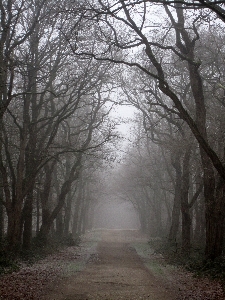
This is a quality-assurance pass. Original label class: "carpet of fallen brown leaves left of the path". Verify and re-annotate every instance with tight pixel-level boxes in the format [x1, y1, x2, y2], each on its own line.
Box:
[0, 247, 81, 300]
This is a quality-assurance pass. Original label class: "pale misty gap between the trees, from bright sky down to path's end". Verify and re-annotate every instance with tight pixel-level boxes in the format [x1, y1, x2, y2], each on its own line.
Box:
[90, 105, 140, 229]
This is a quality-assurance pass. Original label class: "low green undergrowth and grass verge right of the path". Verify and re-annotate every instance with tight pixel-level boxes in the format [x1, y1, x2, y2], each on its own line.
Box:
[131, 238, 225, 298]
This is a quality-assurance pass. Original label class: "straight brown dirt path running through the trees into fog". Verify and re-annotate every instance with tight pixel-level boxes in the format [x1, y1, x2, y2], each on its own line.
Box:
[46, 230, 176, 300]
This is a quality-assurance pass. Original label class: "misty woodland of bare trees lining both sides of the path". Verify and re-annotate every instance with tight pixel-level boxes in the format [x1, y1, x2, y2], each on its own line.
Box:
[0, 0, 225, 276]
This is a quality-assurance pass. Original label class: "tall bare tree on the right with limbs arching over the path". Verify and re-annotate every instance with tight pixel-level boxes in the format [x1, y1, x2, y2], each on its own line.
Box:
[71, 0, 225, 259]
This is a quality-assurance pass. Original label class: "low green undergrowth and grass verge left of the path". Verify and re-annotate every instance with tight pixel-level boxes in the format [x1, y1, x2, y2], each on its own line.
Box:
[0, 230, 102, 276]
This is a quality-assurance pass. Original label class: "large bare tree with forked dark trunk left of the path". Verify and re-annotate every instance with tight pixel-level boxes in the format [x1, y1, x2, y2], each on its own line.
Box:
[0, 1, 118, 254]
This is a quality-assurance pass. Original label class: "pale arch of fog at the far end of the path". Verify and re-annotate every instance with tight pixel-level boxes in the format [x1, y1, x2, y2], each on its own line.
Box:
[93, 199, 140, 229]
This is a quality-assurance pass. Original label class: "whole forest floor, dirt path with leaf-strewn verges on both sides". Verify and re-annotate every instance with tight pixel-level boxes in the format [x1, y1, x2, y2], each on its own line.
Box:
[0, 230, 225, 300]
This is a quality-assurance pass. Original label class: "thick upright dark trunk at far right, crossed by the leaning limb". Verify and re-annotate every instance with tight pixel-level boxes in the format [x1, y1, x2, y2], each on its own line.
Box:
[176, 4, 224, 259]
